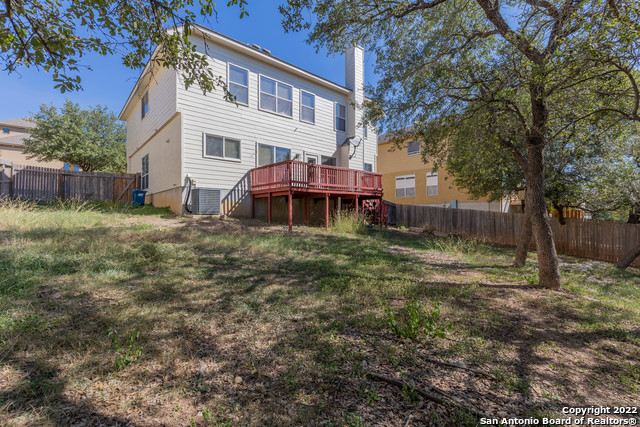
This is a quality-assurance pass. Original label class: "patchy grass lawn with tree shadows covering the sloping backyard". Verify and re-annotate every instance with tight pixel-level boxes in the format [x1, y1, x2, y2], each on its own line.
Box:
[0, 203, 640, 426]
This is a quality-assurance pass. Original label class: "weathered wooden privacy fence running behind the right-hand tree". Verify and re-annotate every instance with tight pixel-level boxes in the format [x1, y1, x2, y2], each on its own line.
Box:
[396, 205, 640, 267]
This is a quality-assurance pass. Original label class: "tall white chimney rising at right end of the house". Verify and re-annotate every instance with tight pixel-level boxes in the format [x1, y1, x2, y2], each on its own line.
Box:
[344, 46, 364, 169]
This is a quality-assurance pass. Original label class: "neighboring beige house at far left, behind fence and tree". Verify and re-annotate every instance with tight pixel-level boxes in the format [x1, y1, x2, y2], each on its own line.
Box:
[0, 118, 64, 169]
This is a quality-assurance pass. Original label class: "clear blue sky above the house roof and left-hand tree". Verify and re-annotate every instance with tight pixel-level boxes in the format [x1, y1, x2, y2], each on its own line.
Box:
[0, 1, 375, 119]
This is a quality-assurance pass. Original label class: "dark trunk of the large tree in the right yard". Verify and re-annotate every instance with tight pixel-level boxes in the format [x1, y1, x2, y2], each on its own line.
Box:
[525, 78, 560, 289]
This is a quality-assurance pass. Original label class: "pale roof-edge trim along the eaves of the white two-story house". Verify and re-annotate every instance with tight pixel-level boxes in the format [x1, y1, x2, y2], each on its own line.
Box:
[118, 24, 352, 120]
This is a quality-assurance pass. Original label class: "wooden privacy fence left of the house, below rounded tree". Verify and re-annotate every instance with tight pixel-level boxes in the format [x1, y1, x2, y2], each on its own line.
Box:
[0, 160, 140, 202]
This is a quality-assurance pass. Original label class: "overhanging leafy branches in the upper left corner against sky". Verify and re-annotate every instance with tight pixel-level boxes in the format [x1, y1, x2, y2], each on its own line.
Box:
[0, 0, 247, 92]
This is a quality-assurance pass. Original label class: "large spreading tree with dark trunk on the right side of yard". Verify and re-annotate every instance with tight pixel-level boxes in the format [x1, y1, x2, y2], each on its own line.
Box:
[281, 0, 633, 289]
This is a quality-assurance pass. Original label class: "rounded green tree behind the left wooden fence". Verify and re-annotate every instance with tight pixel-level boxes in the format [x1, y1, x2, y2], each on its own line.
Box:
[24, 101, 127, 172]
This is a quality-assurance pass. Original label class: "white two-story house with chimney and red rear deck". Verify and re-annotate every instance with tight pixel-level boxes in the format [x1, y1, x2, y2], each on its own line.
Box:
[120, 26, 381, 229]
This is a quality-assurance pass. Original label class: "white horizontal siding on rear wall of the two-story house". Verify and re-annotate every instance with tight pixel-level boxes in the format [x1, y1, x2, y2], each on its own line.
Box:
[178, 35, 356, 190]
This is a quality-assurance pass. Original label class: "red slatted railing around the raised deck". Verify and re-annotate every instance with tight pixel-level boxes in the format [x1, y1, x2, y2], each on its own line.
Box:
[251, 160, 382, 194]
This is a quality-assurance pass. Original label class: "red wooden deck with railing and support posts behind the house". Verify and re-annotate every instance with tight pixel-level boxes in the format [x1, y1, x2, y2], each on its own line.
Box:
[251, 160, 382, 230]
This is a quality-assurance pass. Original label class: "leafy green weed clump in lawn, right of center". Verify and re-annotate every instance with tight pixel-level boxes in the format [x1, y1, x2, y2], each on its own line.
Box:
[385, 302, 446, 340]
